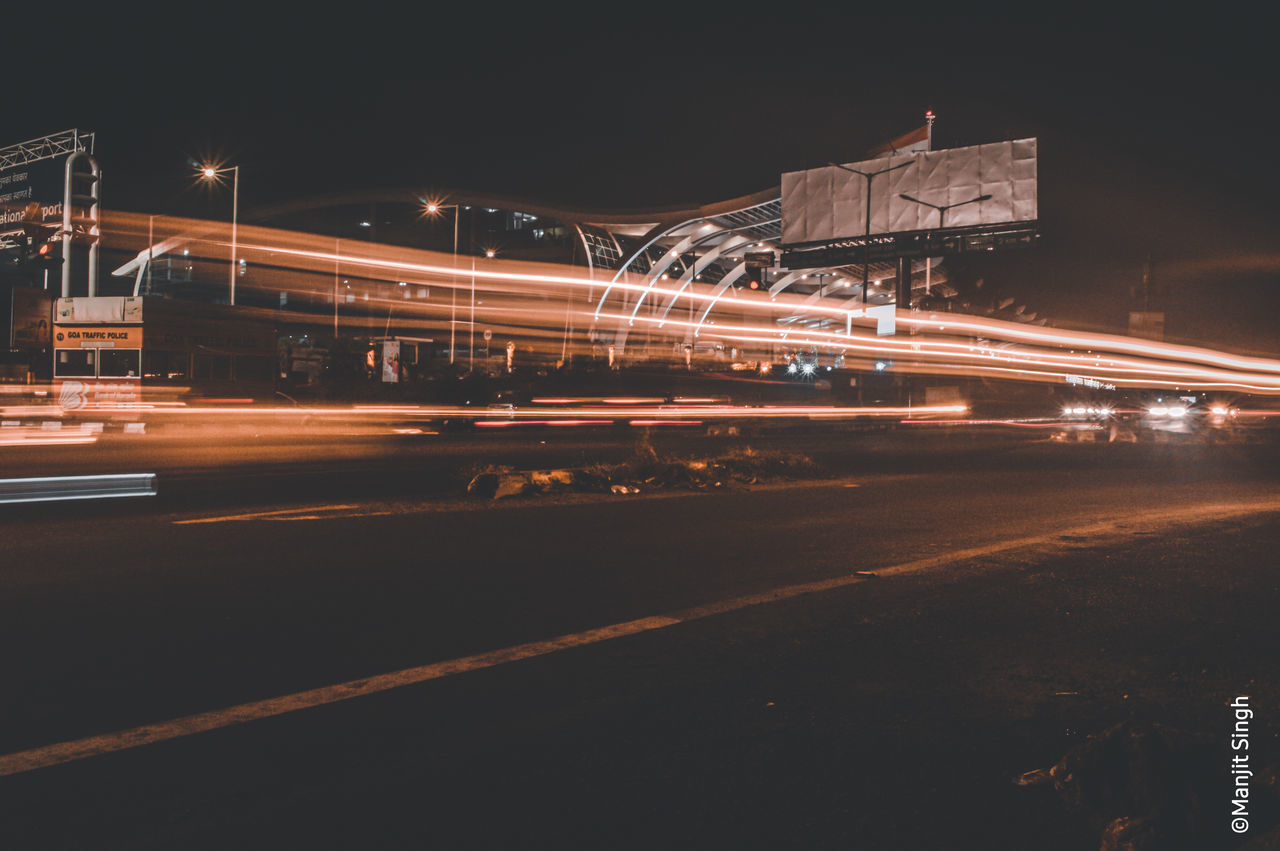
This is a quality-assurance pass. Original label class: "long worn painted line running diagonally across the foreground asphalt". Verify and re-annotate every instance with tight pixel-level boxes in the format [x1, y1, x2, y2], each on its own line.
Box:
[0, 499, 1280, 777]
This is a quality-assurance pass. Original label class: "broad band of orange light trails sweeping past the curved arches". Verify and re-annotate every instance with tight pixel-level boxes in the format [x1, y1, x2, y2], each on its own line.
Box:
[92, 214, 1280, 394]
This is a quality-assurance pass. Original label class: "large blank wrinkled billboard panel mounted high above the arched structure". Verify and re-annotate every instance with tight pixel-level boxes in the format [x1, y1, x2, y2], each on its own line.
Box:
[782, 138, 1038, 246]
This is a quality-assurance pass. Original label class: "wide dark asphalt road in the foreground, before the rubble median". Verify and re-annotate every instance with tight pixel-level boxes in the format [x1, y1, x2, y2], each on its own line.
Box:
[0, 443, 1280, 848]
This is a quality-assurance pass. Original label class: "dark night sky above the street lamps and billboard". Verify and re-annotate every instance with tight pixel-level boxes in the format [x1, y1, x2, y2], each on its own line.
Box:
[10, 4, 1280, 352]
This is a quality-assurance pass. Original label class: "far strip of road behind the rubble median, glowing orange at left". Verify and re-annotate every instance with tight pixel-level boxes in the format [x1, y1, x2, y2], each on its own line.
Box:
[0, 421, 1044, 506]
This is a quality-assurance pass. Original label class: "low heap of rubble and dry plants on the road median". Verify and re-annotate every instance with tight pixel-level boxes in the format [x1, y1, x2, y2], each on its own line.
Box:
[467, 445, 824, 499]
